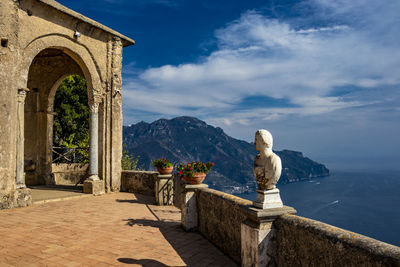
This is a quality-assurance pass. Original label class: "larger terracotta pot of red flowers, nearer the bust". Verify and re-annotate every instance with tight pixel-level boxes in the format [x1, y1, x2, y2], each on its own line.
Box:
[177, 161, 214, 184]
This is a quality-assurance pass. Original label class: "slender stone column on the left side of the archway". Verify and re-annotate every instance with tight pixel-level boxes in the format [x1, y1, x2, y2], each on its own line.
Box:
[16, 89, 29, 189]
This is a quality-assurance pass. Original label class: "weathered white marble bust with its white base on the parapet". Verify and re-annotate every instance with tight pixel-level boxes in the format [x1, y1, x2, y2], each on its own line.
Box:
[253, 129, 283, 209]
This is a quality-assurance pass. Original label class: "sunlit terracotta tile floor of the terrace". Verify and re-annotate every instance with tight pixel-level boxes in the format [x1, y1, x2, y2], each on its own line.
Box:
[0, 193, 236, 267]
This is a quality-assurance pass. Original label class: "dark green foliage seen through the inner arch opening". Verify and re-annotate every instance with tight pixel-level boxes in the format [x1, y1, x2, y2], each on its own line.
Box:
[53, 75, 89, 163]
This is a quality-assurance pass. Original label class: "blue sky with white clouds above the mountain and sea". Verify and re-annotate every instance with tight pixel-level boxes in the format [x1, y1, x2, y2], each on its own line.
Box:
[59, 0, 400, 169]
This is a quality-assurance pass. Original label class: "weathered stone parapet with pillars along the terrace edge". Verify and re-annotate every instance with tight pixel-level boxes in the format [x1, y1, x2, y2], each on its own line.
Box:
[121, 171, 400, 266]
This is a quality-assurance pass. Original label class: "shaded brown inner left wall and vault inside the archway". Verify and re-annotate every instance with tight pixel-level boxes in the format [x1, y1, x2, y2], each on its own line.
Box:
[24, 48, 90, 186]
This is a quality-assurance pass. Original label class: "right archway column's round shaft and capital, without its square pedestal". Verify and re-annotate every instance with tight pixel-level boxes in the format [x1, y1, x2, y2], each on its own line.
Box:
[89, 102, 99, 181]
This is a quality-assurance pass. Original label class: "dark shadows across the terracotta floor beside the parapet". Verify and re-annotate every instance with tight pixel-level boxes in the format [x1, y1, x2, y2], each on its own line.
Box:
[116, 194, 237, 266]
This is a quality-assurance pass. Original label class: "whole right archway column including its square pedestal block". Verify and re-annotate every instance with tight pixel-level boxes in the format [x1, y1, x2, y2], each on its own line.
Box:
[83, 102, 105, 195]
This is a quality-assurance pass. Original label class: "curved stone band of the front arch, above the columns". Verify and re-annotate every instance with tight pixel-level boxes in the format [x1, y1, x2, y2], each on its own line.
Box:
[18, 34, 103, 103]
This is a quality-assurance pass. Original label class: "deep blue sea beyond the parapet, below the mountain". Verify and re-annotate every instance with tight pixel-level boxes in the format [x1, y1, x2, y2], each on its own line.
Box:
[237, 170, 400, 246]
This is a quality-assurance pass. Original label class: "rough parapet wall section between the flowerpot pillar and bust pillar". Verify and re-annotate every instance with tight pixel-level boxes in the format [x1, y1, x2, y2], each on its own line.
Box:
[196, 188, 252, 263]
